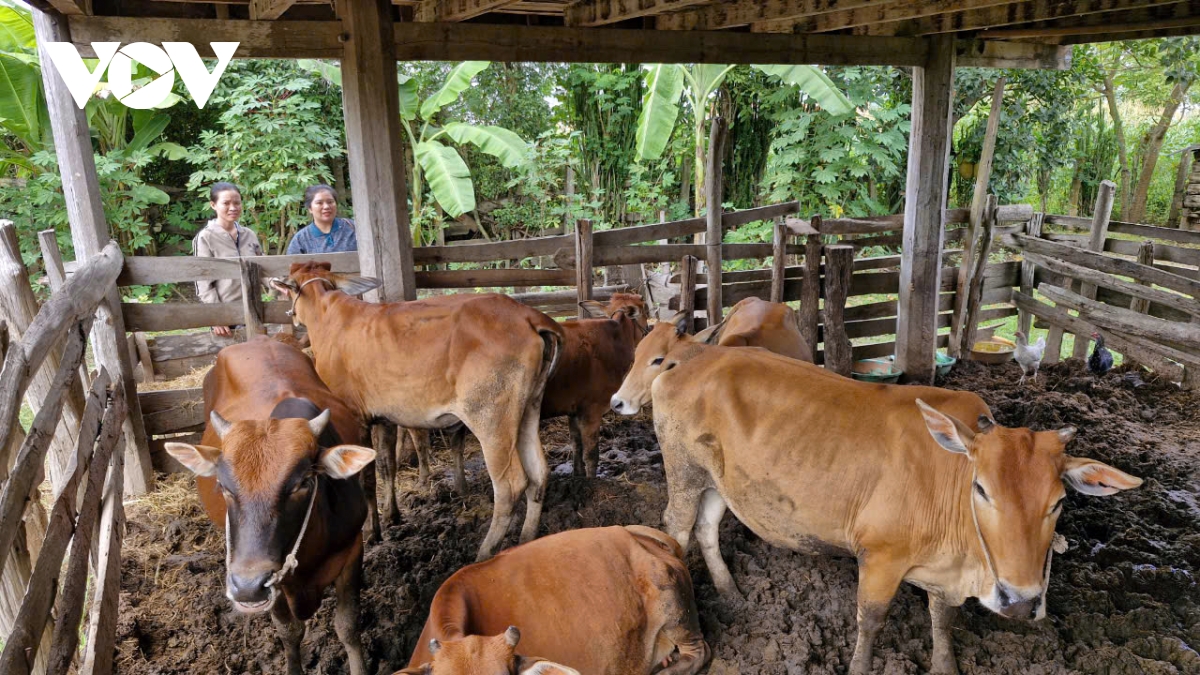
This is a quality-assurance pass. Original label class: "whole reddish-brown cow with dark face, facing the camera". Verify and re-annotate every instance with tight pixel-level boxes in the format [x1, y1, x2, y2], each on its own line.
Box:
[166, 338, 374, 675]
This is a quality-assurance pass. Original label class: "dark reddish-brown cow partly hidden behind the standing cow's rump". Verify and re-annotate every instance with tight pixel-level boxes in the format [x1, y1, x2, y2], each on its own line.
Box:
[541, 293, 649, 478]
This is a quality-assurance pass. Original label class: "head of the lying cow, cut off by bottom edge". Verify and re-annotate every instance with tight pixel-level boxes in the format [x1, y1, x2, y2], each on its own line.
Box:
[396, 626, 580, 675]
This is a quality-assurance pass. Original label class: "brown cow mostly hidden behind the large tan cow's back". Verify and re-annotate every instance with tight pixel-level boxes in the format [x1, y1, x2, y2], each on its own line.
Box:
[695, 298, 812, 363]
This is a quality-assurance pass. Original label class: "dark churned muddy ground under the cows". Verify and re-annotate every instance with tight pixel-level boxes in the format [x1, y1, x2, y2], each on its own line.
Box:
[118, 362, 1200, 675]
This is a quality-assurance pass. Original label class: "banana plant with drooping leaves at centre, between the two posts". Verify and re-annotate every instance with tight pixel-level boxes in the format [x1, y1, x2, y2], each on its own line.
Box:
[636, 64, 854, 216]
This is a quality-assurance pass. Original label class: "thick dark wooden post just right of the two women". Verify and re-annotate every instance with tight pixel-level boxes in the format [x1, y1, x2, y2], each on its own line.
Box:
[340, 0, 416, 301]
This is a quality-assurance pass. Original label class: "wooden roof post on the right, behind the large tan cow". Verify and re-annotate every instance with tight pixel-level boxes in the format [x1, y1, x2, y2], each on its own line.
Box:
[895, 35, 954, 384]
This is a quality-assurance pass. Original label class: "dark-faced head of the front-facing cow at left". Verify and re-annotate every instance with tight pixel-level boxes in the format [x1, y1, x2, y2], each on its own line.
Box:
[166, 410, 374, 613]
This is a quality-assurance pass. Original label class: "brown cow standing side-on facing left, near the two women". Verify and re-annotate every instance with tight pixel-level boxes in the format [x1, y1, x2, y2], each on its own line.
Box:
[271, 263, 563, 560]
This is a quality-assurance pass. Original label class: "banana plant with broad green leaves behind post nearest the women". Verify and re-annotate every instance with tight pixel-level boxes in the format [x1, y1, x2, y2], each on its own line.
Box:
[300, 61, 529, 246]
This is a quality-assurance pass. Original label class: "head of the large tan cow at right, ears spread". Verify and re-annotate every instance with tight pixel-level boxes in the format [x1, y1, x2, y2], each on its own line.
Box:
[917, 399, 1141, 619]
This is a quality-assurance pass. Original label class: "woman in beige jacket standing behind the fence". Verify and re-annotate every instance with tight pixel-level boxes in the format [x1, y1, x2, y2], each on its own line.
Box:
[192, 183, 263, 338]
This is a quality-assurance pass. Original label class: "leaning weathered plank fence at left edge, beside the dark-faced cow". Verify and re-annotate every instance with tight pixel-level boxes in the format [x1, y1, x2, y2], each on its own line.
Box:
[0, 243, 126, 675]
